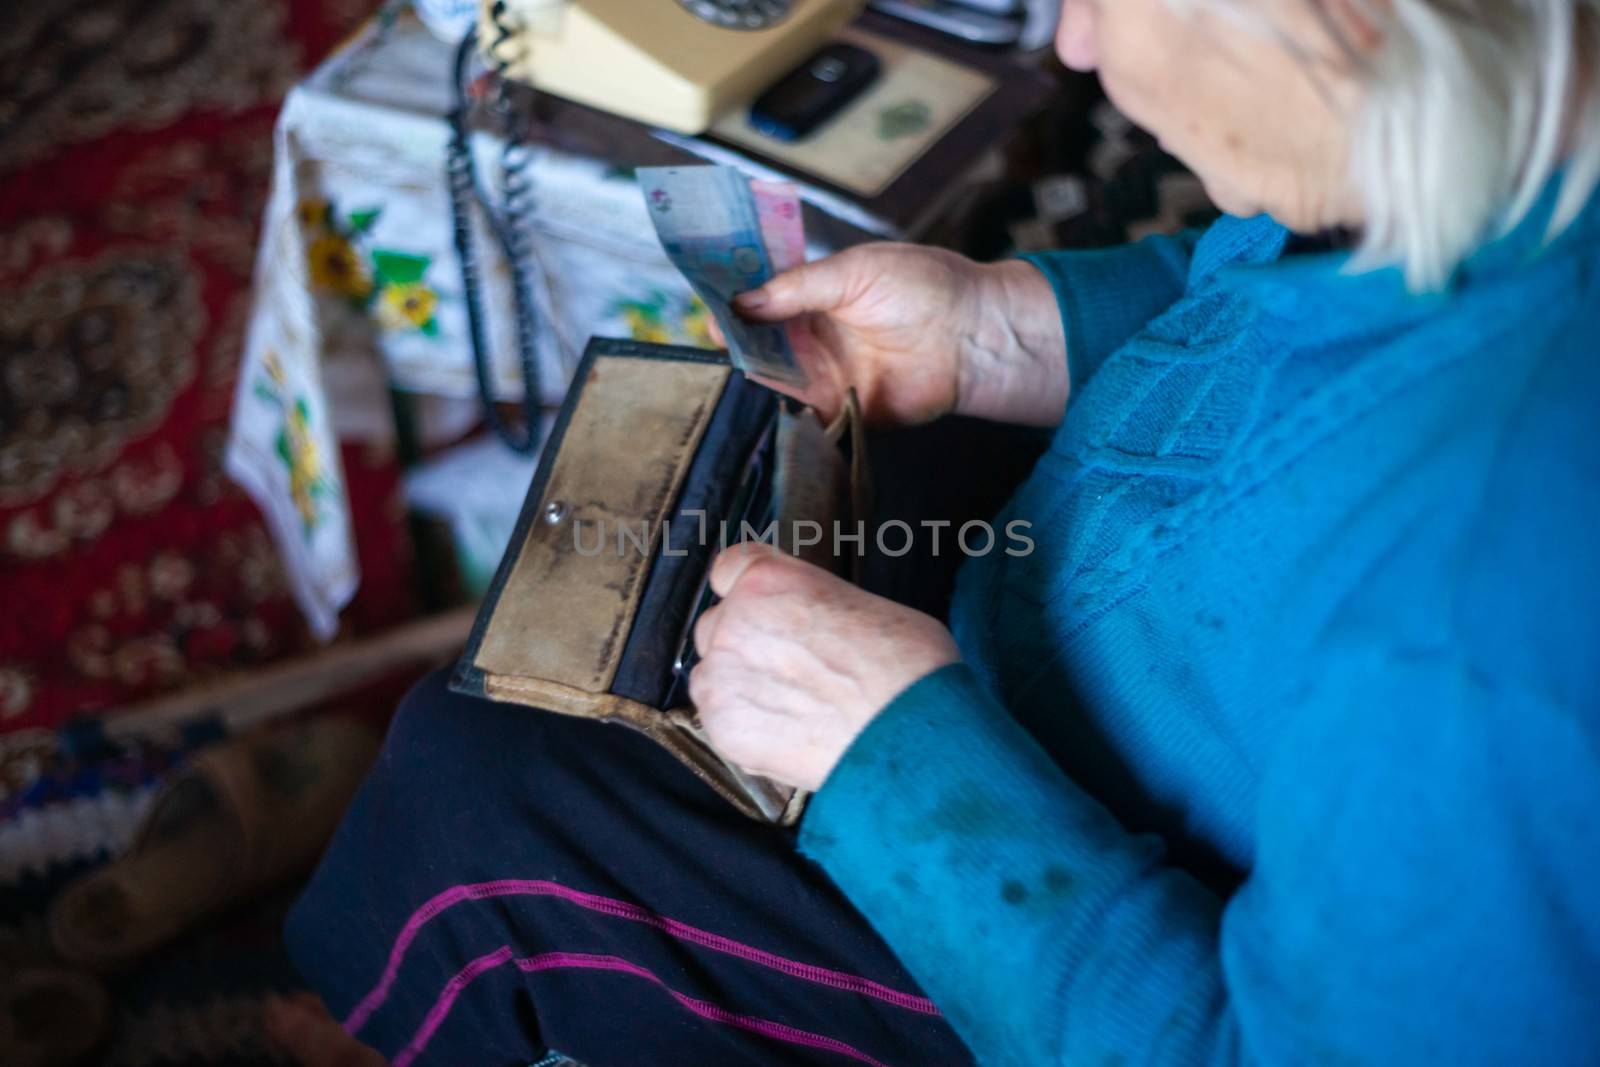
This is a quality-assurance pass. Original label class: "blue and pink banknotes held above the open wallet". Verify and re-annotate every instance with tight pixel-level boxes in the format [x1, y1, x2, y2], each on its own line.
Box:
[638, 166, 806, 386]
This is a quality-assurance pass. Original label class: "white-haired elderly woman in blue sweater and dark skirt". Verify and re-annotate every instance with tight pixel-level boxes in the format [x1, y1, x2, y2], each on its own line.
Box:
[291, 0, 1600, 1067]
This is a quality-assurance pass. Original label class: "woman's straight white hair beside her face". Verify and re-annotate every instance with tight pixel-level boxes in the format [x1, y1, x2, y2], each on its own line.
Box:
[1350, 0, 1600, 291]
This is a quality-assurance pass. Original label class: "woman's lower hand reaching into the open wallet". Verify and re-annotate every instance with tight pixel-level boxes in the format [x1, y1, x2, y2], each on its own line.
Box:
[690, 542, 960, 789]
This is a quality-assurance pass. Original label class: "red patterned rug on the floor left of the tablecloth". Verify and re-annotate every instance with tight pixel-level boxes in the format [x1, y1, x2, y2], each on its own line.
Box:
[0, 0, 414, 733]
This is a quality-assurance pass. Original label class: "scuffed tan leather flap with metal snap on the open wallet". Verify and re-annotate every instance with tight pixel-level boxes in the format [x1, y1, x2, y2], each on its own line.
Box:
[474, 355, 730, 697]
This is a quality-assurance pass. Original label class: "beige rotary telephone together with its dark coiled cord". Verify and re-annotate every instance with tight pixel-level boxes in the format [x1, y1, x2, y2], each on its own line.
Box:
[446, 0, 862, 453]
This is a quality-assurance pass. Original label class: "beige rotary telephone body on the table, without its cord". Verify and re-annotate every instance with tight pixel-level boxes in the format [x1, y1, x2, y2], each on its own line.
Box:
[478, 0, 862, 134]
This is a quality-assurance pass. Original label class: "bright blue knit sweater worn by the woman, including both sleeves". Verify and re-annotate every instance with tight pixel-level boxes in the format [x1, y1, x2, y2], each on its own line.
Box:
[802, 187, 1600, 1067]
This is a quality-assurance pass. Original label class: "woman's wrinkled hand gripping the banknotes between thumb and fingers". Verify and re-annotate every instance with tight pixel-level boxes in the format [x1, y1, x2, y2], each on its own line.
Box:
[720, 243, 1067, 426]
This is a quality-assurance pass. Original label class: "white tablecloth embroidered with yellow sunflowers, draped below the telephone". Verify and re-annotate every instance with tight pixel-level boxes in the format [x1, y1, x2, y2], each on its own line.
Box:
[227, 14, 707, 638]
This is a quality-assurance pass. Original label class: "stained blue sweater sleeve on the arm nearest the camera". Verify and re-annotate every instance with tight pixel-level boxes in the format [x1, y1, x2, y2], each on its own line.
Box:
[802, 654, 1600, 1067]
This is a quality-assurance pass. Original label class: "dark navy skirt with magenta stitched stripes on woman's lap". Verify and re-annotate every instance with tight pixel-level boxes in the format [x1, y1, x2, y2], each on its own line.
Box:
[286, 673, 971, 1067]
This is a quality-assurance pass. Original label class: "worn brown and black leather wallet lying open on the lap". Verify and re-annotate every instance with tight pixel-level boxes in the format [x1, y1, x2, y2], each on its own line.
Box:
[451, 338, 867, 825]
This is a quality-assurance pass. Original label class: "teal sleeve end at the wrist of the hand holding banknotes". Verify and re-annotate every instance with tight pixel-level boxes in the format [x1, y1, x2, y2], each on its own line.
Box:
[1021, 230, 1200, 389]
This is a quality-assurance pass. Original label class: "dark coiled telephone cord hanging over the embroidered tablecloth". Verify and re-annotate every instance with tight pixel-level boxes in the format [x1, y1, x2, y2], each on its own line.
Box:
[445, 12, 541, 454]
